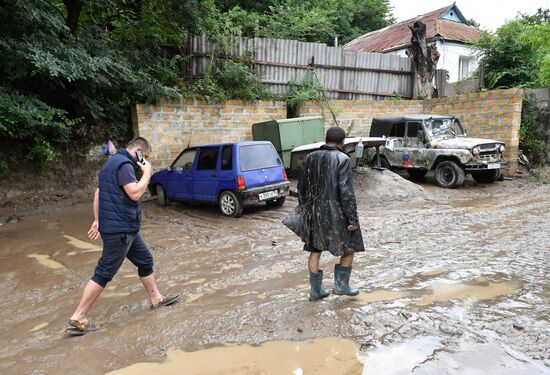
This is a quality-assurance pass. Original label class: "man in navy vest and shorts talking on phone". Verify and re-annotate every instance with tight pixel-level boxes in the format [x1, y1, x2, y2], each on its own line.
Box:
[66, 137, 179, 335]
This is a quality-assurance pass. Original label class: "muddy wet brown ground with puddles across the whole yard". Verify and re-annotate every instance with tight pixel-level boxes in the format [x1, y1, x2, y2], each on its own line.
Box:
[0, 172, 550, 375]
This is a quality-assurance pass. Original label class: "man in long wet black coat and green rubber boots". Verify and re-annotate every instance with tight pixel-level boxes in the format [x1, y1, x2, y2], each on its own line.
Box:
[298, 127, 365, 301]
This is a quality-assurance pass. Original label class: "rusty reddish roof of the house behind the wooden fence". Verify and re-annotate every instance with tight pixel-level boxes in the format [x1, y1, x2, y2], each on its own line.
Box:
[344, 4, 481, 52]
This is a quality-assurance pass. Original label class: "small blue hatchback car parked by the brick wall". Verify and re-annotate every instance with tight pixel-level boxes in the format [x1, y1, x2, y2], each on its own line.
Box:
[149, 142, 290, 217]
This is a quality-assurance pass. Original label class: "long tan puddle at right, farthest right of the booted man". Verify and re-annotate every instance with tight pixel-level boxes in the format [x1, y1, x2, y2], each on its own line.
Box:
[416, 278, 521, 306]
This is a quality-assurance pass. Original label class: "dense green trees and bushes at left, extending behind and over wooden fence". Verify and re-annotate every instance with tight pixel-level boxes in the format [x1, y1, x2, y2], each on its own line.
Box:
[0, 0, 392, 172]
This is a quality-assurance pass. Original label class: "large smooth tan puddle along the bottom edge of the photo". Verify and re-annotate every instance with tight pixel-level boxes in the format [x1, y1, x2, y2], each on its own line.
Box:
[109, 338, 363, 375]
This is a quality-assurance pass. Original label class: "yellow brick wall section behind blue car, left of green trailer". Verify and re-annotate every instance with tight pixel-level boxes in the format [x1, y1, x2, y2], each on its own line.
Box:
[132, 99, 286, 170]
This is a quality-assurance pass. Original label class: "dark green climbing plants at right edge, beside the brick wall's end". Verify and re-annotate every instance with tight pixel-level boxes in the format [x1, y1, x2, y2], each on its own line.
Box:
[519, 95, 550, 167]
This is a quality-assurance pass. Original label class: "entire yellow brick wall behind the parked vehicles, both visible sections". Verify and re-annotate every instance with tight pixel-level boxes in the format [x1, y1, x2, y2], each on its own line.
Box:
[133, 89, 523, 173]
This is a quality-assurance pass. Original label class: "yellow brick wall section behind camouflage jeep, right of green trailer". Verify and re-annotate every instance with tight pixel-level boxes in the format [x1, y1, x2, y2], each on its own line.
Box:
[300, 89, 523, 173]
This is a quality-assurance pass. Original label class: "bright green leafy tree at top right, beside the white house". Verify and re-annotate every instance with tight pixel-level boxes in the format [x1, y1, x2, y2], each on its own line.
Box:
[477, 9, 550, 89]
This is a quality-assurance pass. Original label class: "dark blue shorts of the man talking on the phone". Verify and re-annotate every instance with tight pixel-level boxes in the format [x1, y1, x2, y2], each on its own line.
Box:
[92, 232, 153, 287]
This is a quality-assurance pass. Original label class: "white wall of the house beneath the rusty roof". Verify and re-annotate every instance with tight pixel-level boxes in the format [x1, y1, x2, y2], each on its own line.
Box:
[388, 40, 479, 82]
